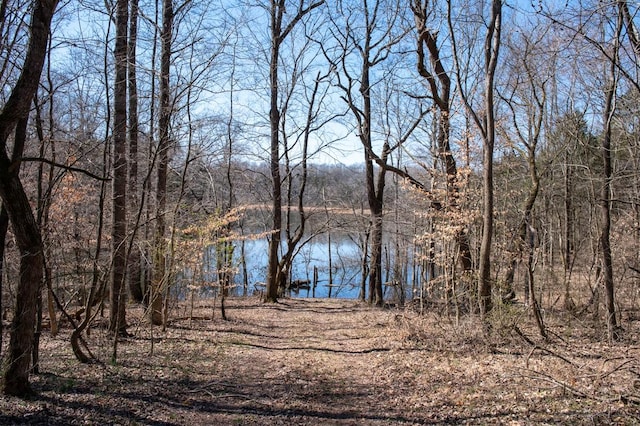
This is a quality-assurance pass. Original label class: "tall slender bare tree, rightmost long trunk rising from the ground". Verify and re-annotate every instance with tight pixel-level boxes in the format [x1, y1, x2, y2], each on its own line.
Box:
[544, 1, 640, 340]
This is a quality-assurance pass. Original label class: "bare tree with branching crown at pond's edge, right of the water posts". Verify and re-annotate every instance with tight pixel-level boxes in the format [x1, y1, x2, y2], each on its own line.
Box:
[325, 0, 422, 306]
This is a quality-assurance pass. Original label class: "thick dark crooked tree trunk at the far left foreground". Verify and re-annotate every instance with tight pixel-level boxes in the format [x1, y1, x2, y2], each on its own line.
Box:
[0, 0, 58, 396]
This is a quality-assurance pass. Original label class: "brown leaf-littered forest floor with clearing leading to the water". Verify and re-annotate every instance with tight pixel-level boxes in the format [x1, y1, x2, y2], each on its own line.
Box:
[0, 298, 640, 426]
